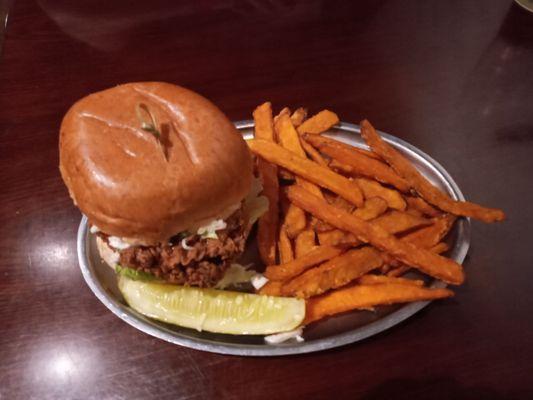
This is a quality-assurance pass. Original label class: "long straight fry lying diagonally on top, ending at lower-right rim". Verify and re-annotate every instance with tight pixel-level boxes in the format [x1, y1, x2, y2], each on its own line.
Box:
[287, 186, 464, 284]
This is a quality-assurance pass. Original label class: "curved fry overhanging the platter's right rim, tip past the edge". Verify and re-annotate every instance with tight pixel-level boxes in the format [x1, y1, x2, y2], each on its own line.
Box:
[361, 120, 505, 222]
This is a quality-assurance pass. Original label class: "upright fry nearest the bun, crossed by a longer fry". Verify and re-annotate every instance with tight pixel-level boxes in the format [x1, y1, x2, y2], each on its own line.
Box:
[253, 102, 279, 265]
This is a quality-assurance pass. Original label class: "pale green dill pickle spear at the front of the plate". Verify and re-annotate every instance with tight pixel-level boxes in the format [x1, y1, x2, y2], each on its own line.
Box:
[118, 275, 305, 335]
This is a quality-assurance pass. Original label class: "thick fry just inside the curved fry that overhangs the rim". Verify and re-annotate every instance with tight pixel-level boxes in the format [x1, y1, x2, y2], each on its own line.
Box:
[305, 135, 409, 192]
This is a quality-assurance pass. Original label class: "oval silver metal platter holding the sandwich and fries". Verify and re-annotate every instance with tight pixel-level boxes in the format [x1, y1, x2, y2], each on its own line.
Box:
[78, 121, 470, 356]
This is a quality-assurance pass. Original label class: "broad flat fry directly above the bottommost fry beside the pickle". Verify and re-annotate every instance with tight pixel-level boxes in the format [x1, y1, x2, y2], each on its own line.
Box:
[281, 246, 383, 298]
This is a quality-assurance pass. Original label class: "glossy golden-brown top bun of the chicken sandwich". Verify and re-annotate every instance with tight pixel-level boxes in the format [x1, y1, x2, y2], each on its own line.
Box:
[59, 82, 252, 244]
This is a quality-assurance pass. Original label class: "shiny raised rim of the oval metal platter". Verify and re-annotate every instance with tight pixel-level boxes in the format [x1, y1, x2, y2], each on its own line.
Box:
[77, 120, 471, 356]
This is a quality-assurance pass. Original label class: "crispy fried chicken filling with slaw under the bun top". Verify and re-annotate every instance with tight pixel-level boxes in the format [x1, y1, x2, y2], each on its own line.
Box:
[91, 179, 268, 287]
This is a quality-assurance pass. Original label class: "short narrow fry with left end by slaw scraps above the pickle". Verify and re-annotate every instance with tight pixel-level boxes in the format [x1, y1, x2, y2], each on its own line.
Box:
[265, 246, 343, 281]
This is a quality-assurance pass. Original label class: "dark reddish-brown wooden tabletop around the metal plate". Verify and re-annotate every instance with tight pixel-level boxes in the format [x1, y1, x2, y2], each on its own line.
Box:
[0, 0, 533, 399]
